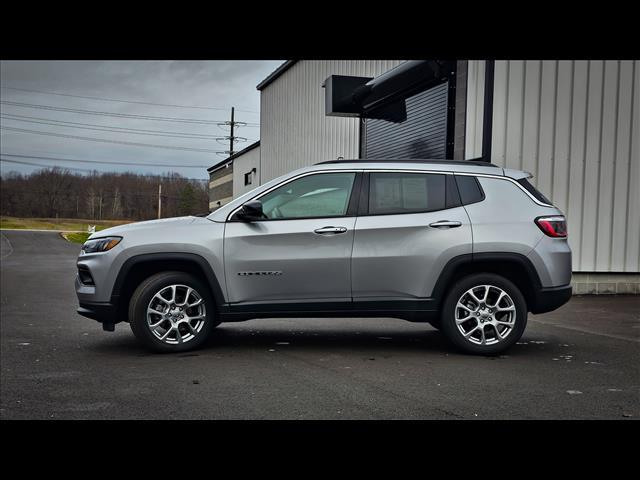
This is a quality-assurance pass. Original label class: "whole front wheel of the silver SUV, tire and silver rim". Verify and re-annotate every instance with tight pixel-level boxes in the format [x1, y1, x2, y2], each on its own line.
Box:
[129, 272, 220, 353]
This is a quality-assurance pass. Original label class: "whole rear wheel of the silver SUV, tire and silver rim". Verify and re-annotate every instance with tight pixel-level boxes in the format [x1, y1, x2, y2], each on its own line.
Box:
[440, 273, 527, 355]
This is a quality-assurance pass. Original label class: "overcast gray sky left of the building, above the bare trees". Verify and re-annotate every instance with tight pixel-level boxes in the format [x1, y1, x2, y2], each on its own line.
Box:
[0, 60, 282, 179]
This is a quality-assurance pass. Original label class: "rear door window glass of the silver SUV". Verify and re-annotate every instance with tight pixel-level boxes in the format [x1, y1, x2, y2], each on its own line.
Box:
[369, 172, 446, 215]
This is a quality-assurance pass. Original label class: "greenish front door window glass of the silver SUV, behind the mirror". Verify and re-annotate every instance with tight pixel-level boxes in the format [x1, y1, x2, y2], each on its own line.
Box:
[260, 172, 356, 220]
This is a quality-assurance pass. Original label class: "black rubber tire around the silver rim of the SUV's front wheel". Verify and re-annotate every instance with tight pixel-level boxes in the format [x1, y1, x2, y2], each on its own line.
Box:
[129, 272, 220, 353]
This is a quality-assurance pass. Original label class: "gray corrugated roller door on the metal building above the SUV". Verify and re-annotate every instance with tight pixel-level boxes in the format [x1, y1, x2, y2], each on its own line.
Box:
[362, 81, 449, 159]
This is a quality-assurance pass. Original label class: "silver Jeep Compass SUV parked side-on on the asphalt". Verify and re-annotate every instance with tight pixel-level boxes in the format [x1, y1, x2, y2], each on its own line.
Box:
[76, 160, 571, 354]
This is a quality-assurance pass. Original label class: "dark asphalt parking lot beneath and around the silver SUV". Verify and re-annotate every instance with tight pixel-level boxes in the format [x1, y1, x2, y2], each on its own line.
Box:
[0, 231, 640, 420]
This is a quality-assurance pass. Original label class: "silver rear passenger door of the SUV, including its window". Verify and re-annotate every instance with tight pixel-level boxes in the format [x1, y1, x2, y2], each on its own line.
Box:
[352, 171, 472, 302]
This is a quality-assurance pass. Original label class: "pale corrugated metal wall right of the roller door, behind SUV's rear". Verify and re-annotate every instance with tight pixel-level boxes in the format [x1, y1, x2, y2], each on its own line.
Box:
[465, 60, 640, 272]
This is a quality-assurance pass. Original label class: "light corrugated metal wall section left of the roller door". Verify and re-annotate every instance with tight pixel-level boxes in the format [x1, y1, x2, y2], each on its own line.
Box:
[259, 60, 402, 183]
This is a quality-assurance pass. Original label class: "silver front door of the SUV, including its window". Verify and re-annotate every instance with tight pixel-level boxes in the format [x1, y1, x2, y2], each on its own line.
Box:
[224, 171, 360, 303]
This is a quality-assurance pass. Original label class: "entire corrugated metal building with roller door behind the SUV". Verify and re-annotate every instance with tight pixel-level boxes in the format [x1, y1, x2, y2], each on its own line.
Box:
[210, 60, 640, 293]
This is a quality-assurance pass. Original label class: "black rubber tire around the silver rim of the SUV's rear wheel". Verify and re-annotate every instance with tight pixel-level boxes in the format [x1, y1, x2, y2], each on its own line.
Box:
[440, 273, 527, 355]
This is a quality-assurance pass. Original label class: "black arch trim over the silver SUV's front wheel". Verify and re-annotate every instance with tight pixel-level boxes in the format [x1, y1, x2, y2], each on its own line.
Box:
[111, 252, 225, 305]
